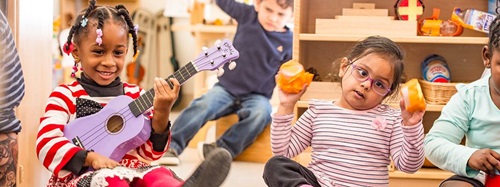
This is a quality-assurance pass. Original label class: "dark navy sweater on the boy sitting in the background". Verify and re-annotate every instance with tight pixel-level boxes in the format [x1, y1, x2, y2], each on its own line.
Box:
[216, 0, 293, 98]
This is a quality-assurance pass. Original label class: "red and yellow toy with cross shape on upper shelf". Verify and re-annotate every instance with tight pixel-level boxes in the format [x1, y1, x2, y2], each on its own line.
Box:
[394, 0, 425, 20]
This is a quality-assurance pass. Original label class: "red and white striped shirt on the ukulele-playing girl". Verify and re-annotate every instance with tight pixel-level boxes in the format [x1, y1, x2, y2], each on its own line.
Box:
[36, 81, 168, 181]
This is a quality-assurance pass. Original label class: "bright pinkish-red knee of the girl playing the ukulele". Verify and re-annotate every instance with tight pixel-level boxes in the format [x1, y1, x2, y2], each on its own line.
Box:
[130, 167, 184, 187]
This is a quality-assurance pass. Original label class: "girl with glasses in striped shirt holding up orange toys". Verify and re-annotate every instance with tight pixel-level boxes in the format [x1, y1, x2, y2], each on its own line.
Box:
[264, 36, 424, 186]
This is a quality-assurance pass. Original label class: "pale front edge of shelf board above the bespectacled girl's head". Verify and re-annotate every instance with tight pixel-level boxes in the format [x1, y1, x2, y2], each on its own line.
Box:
[299, 34, 488, 45]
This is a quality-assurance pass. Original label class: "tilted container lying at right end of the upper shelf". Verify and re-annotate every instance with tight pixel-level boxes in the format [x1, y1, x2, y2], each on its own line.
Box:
[451, 7, 496, 33]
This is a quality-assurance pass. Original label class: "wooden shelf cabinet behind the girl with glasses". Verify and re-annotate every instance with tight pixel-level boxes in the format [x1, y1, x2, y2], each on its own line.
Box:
[293, 0, 488, 186]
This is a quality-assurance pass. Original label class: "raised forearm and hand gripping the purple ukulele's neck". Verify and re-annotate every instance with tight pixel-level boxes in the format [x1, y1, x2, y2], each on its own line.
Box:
[137, 78, 180, 160]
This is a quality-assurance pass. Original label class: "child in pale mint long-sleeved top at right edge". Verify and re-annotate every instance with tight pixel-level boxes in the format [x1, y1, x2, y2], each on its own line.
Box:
[424, 13, 500, 187]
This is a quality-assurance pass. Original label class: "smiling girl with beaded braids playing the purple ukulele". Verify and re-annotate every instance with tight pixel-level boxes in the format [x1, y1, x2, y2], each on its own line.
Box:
[36, 0, 232, 187]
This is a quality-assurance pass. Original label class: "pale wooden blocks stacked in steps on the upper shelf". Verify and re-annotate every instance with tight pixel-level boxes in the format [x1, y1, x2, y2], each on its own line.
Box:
[315, 3, 417, 36]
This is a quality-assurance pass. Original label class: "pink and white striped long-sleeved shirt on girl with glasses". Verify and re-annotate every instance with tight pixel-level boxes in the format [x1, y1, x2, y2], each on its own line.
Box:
[271, 100, 424, 186]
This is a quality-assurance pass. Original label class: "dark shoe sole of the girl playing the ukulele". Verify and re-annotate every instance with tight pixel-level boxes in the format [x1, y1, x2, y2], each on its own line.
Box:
[182, 148, 232, 187]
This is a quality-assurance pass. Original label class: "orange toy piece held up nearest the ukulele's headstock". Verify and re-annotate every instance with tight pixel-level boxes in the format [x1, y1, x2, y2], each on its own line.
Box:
[276, 60, 314, 93]
